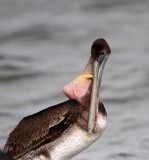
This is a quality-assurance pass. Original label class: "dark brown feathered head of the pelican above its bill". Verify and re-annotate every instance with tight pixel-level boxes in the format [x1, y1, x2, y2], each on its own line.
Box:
[91, 38, 111, 59]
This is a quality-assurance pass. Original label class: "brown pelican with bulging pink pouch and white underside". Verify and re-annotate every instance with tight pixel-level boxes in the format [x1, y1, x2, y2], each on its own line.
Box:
[4, 38, 111, 160]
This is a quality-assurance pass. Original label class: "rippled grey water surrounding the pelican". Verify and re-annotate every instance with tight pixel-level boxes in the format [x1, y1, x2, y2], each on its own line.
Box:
[0, 0, 149, 160]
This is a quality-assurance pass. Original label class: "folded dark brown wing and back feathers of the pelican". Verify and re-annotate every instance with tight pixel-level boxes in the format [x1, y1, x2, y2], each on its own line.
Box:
[4, 100, 84, 159]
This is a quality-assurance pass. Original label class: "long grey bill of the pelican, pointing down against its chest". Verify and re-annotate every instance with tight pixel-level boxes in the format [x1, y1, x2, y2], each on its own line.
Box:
[88, 53, 109, 134]
